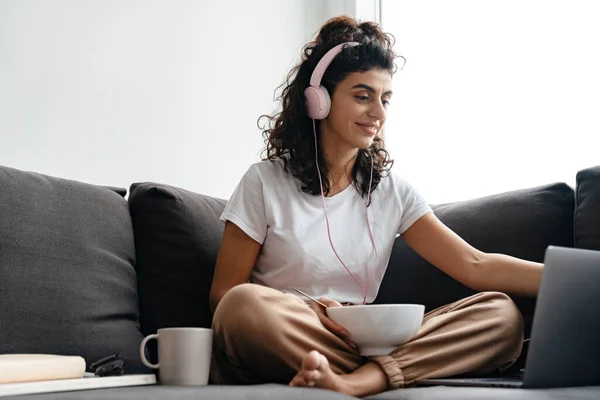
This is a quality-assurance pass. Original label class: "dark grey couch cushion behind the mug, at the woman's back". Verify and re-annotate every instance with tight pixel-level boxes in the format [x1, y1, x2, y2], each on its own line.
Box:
[129, 182, 226, 359]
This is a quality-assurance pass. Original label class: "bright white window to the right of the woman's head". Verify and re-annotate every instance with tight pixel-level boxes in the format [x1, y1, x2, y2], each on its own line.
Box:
[379, 0, 600, 203]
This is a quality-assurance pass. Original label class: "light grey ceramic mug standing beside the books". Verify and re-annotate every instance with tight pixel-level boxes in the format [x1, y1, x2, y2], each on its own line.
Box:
[140, 328, 213, 386]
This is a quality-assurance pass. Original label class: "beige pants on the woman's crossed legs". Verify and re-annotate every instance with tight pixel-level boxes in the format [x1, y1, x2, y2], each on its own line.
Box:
[211, 284, 523, 389]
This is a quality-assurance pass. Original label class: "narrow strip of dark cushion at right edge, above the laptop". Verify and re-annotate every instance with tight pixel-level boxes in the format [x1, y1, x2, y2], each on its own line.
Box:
[575, 165, 600, 250]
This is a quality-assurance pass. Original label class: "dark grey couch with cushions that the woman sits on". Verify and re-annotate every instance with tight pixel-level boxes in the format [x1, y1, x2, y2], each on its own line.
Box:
[0, 166, 600, 400]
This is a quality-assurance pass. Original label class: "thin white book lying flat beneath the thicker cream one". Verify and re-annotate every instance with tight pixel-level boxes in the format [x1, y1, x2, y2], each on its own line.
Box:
[0, 374, 156, 397]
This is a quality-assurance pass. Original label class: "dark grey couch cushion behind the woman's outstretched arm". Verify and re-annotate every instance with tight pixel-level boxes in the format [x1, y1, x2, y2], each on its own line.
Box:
[376, 183, 574, 372]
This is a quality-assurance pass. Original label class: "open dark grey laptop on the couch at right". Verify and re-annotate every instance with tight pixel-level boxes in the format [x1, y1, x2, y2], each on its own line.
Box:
[416, 246, 600, 388]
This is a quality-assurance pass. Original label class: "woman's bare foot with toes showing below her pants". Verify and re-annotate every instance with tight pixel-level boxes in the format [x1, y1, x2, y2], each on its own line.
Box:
[290, 350, 348, 394]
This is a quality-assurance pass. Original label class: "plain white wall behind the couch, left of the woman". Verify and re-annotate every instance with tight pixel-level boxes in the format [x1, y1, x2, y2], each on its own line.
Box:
[0, 0, 356, 198]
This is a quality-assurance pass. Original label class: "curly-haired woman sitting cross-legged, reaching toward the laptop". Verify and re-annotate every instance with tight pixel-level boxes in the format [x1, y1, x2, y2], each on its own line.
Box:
[210, 17, 542, 396]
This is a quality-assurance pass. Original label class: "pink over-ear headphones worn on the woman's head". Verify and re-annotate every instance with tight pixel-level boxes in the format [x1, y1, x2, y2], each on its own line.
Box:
[304, 42, 360, 119]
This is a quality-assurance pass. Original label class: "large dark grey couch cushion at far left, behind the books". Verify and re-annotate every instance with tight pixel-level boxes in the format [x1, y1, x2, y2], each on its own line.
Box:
[0, 167, 146, 372]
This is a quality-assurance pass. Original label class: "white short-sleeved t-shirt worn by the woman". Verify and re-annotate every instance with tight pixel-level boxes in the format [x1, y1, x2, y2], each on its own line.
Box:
[221, 160, 432, 304]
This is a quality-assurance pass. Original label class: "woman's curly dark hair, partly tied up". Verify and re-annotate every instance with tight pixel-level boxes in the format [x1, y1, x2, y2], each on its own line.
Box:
[258, 16, 404, 202]
